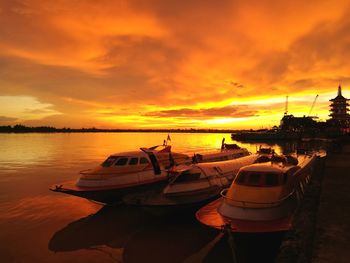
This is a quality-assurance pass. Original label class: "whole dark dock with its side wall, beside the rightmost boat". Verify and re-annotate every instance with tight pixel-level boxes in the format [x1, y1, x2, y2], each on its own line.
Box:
[276, 144, 350, 263]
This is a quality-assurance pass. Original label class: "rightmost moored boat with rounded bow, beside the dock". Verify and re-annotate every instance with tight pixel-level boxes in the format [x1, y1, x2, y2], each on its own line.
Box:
[196, 153, 323, 233]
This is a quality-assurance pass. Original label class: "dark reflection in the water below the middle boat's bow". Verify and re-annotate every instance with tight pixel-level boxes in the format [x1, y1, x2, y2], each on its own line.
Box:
[123, 214, 218, 263]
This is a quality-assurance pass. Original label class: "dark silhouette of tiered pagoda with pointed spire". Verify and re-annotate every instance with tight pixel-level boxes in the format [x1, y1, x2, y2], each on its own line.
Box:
[329, 85, 350, 129]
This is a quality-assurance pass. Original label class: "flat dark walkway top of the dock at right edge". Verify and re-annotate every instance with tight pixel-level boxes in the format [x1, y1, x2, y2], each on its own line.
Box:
[312, 145, 350, 263]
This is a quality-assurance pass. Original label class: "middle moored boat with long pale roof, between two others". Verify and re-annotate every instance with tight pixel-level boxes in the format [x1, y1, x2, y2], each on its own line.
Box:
[123, 154, 274, 210]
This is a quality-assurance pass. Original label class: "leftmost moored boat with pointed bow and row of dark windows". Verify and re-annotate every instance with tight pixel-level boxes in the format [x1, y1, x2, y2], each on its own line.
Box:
[50, 144, 191, 204]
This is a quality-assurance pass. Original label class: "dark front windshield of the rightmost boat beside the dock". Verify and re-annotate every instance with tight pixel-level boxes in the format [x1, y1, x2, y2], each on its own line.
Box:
[235, 171, 283, 187]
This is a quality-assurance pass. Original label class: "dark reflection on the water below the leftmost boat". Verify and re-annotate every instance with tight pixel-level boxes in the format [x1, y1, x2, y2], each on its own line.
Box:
[48, 206, 149, 252]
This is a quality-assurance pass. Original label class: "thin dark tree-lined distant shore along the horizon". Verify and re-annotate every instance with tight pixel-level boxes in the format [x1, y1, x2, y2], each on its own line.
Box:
[0, 125, 243, 133]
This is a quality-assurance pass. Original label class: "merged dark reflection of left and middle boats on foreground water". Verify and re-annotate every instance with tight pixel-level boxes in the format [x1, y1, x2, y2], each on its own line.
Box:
[48, 206, 217, 262]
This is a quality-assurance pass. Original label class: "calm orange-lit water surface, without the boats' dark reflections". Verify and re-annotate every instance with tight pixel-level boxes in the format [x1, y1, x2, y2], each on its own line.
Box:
[0, 133, 292, 263]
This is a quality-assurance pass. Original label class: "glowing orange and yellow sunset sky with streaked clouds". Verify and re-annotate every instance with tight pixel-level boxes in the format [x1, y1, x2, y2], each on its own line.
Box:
[0, 0, 350, 129]
